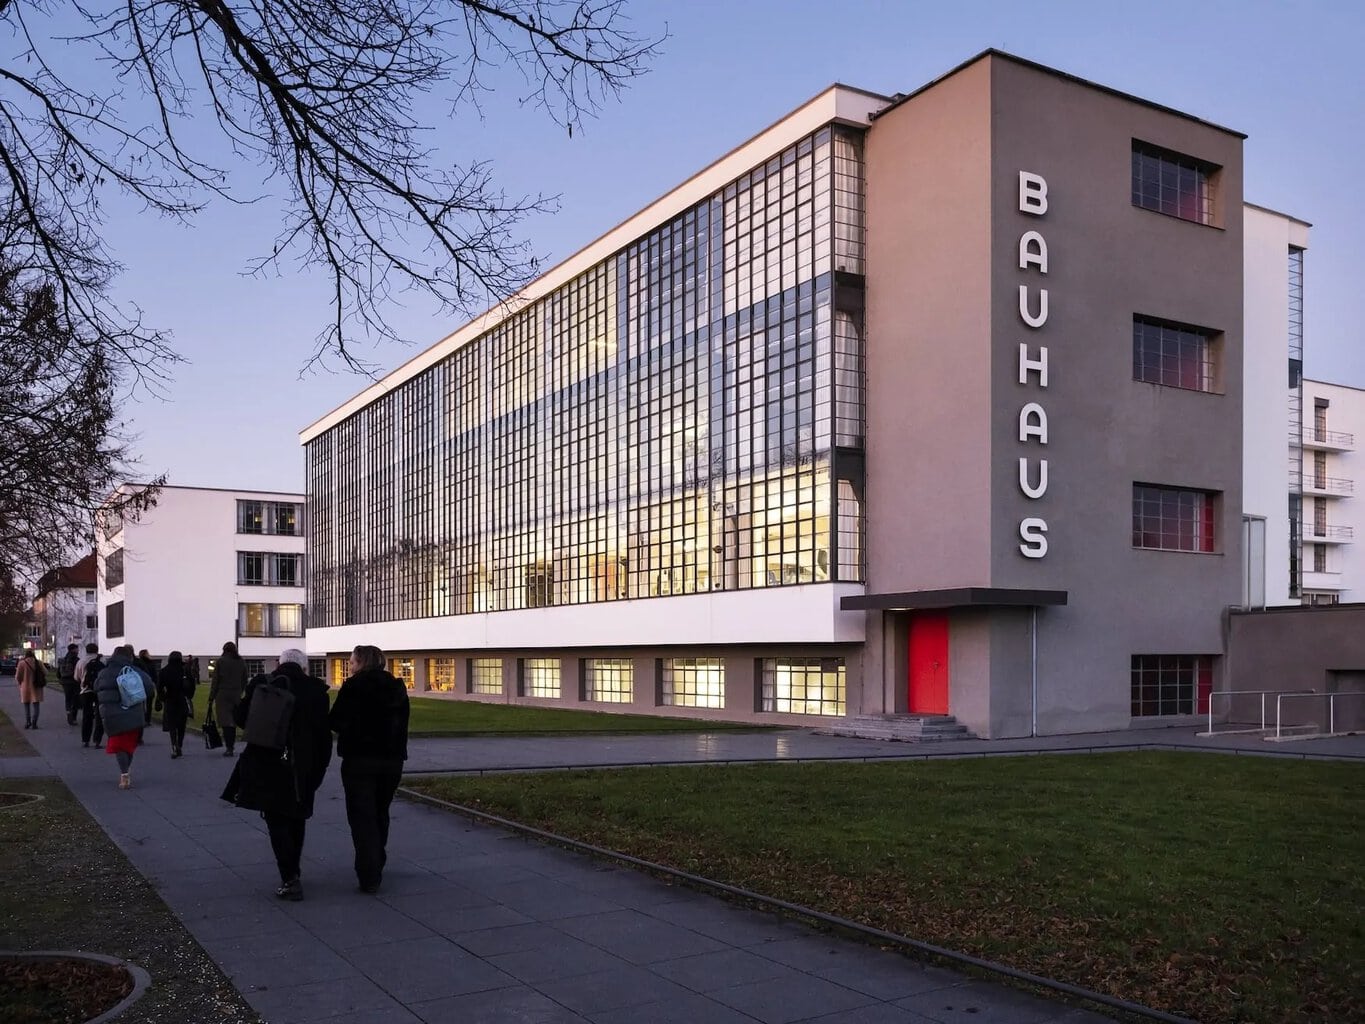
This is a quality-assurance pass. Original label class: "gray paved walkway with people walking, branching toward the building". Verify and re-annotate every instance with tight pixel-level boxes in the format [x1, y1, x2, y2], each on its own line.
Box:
[0, 684, 1365, 1024]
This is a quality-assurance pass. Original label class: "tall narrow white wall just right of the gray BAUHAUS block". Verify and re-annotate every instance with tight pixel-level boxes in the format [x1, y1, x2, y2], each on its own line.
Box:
[1244, 206, 1308, 606]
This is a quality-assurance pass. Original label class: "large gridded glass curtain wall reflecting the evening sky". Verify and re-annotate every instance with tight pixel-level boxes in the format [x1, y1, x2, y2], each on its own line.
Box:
[306, 128, 864, 627]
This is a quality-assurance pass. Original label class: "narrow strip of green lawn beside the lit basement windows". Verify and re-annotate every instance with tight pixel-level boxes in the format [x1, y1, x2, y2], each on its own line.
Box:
[398, 689, 764, 736]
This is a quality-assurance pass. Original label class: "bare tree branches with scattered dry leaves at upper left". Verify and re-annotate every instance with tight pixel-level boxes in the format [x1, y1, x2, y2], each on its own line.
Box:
[0, 0, 657, 584]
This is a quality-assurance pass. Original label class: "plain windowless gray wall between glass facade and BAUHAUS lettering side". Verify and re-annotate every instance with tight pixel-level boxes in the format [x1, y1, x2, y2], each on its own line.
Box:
[865, 63, 991, 593]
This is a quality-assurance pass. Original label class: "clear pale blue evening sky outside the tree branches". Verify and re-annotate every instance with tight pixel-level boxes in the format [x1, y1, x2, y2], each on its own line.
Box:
[79, 0, 1365, 490]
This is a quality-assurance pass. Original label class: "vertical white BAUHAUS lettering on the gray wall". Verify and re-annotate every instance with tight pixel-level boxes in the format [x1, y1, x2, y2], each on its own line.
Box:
[1018, 171, 1047, 558]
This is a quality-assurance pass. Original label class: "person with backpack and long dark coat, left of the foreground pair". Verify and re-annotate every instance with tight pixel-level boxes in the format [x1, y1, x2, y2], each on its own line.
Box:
[222, 647, 332, 901]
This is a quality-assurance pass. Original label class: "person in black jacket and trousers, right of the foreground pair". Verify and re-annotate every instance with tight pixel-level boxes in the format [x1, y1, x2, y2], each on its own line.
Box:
[328, 644, 408, 893]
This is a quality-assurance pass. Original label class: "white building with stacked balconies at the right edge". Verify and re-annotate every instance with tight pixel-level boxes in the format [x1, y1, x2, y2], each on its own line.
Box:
[1299, 380, 1365, 605]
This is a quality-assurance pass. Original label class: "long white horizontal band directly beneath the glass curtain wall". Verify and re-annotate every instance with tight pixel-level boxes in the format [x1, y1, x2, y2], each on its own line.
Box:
[307, 583, 865, 657]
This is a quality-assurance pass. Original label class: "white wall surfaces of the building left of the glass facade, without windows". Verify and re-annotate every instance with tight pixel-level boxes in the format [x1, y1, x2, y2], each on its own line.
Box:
[97, 487, 306, 658]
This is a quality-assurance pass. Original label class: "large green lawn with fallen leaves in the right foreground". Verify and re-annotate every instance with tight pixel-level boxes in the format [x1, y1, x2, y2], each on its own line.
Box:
[408, 752, 1365, 1024]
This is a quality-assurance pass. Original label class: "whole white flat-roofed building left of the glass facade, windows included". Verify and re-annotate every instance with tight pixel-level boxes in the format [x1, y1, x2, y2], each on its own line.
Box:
[97, 485, 304, 670]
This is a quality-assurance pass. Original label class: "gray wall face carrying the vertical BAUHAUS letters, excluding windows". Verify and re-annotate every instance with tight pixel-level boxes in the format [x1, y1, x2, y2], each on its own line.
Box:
[979, 57, 1242, 736]
